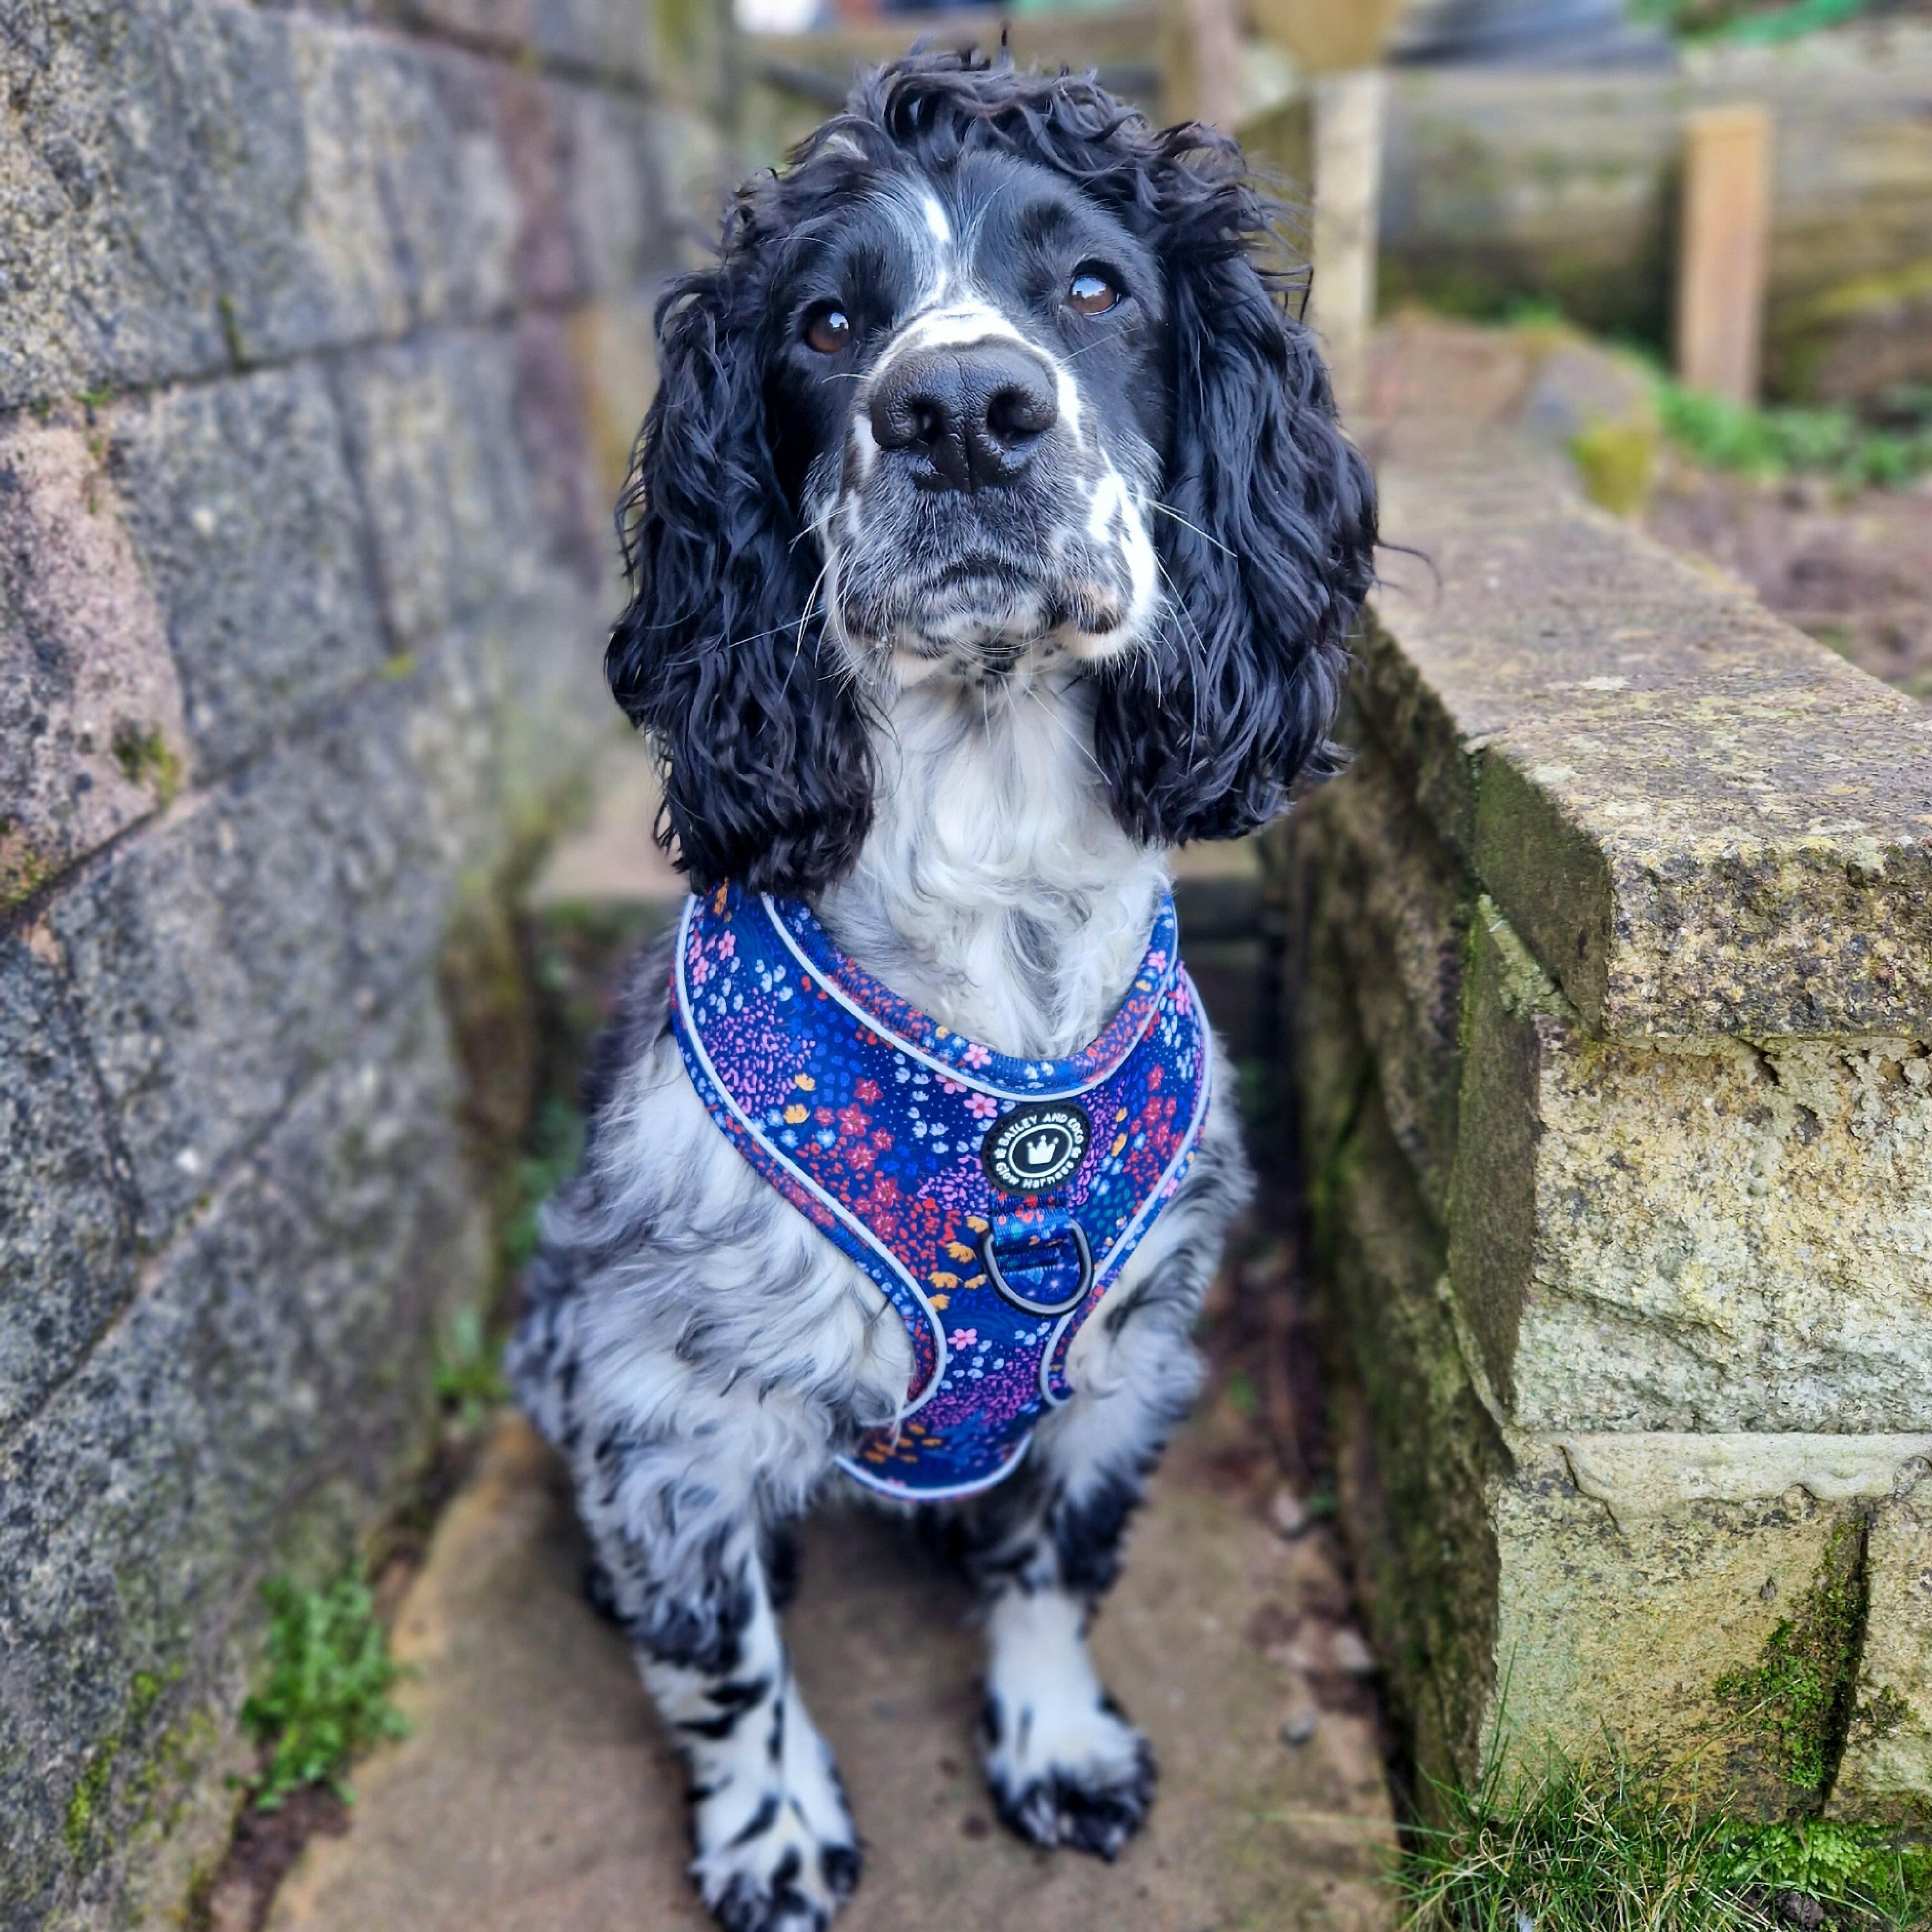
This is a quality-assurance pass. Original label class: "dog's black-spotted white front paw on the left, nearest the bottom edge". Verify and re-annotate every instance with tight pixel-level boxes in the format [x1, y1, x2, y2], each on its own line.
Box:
[692, 1737, 859, 1932]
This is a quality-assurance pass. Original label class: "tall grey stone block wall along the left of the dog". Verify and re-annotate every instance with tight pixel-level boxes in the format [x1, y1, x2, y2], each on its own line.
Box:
[0, 0, 723, 1932]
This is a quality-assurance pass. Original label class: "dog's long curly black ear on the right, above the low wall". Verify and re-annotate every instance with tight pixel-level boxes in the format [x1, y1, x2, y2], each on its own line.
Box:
[1095, 196, 1375, 845]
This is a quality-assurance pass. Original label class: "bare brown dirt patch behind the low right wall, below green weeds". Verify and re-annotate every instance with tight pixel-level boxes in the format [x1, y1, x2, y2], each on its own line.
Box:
[1648, 464, 1932, 701]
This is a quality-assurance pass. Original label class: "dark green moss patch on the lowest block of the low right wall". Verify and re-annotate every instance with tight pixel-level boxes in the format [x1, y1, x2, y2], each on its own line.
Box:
[1714, 1519, 1866, 1812]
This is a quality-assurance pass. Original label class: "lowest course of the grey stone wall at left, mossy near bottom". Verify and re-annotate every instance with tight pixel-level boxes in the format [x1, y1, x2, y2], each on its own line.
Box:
[0, 997, 481, 1928]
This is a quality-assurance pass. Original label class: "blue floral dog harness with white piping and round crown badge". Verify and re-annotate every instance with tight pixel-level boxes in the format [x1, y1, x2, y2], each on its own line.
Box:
[670, 885, 1209, 1501]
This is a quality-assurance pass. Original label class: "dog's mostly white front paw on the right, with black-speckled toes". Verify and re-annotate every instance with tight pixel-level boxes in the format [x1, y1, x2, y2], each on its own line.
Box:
[980, 1690, 1153, 1858]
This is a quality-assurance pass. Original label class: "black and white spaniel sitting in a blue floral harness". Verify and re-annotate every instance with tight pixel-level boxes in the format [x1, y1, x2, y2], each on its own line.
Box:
[510, 52, 1375, 1932]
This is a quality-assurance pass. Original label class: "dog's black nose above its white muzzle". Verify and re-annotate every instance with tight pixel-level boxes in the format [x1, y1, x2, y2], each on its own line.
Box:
[871, 342, 1061, 489]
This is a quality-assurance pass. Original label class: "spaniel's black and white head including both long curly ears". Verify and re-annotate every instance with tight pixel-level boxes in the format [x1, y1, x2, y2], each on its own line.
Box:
[606, 54, 1375, 894]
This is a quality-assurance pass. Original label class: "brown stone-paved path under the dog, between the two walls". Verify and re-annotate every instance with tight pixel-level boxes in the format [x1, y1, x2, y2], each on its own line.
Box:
[269, 1414, 1389, 1932]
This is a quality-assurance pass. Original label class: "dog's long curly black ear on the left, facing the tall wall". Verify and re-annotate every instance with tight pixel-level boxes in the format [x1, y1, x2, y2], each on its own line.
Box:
[604, 263, 871, 898]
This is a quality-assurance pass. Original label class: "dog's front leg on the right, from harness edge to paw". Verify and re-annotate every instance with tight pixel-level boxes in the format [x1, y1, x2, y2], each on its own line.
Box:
[966, 1258, 1198, 1858]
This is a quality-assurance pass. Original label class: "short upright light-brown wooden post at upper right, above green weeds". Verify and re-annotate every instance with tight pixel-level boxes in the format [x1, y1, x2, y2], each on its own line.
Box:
[1677, 103, 1772, 402]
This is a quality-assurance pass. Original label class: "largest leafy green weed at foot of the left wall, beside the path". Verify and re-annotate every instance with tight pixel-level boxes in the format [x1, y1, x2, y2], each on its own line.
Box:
[242, 1576, 409, 1811]
